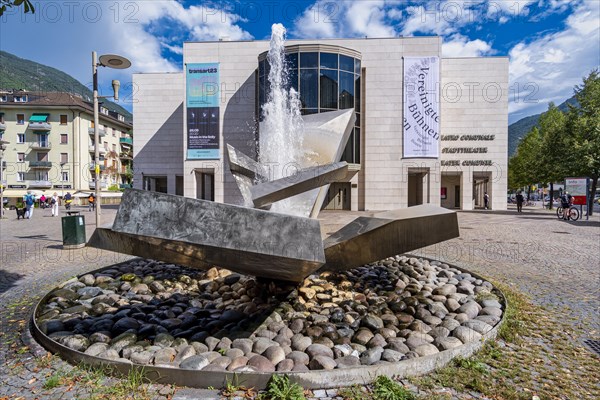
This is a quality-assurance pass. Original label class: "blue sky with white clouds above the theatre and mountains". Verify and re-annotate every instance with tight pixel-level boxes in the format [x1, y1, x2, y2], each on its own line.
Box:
[0, 0, 600, 122]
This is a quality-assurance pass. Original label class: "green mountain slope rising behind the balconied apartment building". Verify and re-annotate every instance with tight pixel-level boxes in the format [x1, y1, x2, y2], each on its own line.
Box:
[0, 51, 133, 122]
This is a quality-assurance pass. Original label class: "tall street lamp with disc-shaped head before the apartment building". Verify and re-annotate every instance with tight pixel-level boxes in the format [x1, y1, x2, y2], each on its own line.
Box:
[92, 51, 131, 228]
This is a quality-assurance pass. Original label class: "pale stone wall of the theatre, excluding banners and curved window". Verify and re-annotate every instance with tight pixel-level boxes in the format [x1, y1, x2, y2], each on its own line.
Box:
[134, 37, 508, 210]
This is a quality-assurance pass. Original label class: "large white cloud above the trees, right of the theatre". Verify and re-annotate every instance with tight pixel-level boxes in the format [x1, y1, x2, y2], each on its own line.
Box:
[509, 0, 600, 119]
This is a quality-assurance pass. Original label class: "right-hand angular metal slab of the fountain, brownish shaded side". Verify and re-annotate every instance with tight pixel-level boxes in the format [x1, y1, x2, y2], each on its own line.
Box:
[323, 204, 459, 271]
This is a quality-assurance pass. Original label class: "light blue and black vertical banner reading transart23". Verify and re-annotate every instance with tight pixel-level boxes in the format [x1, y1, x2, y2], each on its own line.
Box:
[186, 63, 220, 160]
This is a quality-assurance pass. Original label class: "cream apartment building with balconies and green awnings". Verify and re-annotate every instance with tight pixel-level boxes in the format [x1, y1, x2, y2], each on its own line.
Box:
[0, 90, 133, 204]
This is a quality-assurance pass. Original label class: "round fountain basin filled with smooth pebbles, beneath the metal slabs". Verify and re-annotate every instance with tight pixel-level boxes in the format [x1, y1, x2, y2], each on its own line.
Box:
[32, 256, 506, 389]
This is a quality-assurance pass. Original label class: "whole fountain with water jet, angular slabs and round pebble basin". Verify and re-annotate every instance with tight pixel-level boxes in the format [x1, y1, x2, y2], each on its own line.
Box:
[32, 24, 505, 388]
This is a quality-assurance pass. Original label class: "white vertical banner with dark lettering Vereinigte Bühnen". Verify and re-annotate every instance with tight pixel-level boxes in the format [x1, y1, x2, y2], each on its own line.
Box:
[402, 57, 440, 158]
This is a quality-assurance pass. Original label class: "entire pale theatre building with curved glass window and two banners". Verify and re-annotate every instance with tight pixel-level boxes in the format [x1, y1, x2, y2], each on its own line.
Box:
[133, 37, 508, 210]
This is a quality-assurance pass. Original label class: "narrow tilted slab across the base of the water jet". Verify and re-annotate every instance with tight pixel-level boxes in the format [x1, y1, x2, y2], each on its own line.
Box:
[250, 161, 348, 208]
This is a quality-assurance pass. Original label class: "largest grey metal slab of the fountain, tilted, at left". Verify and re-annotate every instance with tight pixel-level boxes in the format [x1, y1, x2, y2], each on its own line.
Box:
[104, 189, 325, 282]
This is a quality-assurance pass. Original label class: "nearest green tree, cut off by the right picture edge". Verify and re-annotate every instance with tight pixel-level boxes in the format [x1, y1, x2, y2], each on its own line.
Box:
[567, 69, 600, 214]
